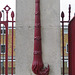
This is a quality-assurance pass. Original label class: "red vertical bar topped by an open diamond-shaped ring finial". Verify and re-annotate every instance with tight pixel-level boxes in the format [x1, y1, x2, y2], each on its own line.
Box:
[4, 5, 11, 75]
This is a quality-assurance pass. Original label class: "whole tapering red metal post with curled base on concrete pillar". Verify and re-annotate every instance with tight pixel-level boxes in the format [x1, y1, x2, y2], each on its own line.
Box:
[32, 0, 49, 75]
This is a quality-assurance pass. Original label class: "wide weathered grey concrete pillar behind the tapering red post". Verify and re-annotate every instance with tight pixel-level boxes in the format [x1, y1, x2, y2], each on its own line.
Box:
[16, 0, 61, 75]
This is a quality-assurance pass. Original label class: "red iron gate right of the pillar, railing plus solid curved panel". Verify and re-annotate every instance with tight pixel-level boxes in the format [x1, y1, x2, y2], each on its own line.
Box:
[60, 5, 75, 75]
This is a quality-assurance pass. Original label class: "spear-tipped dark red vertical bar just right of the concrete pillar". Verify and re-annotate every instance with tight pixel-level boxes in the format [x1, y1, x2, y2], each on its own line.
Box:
[61, 11, 64, 75]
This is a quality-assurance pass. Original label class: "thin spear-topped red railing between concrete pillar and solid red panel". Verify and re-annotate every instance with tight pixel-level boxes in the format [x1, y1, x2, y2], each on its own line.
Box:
[60, 5, 71, 75]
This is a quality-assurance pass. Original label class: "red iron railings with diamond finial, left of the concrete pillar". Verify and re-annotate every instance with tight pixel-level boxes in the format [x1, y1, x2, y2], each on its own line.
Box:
[0, 5, 15, 75]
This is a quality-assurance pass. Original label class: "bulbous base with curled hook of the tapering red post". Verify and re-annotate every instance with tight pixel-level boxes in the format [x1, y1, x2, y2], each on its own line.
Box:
[32, 61, 50, 75]
